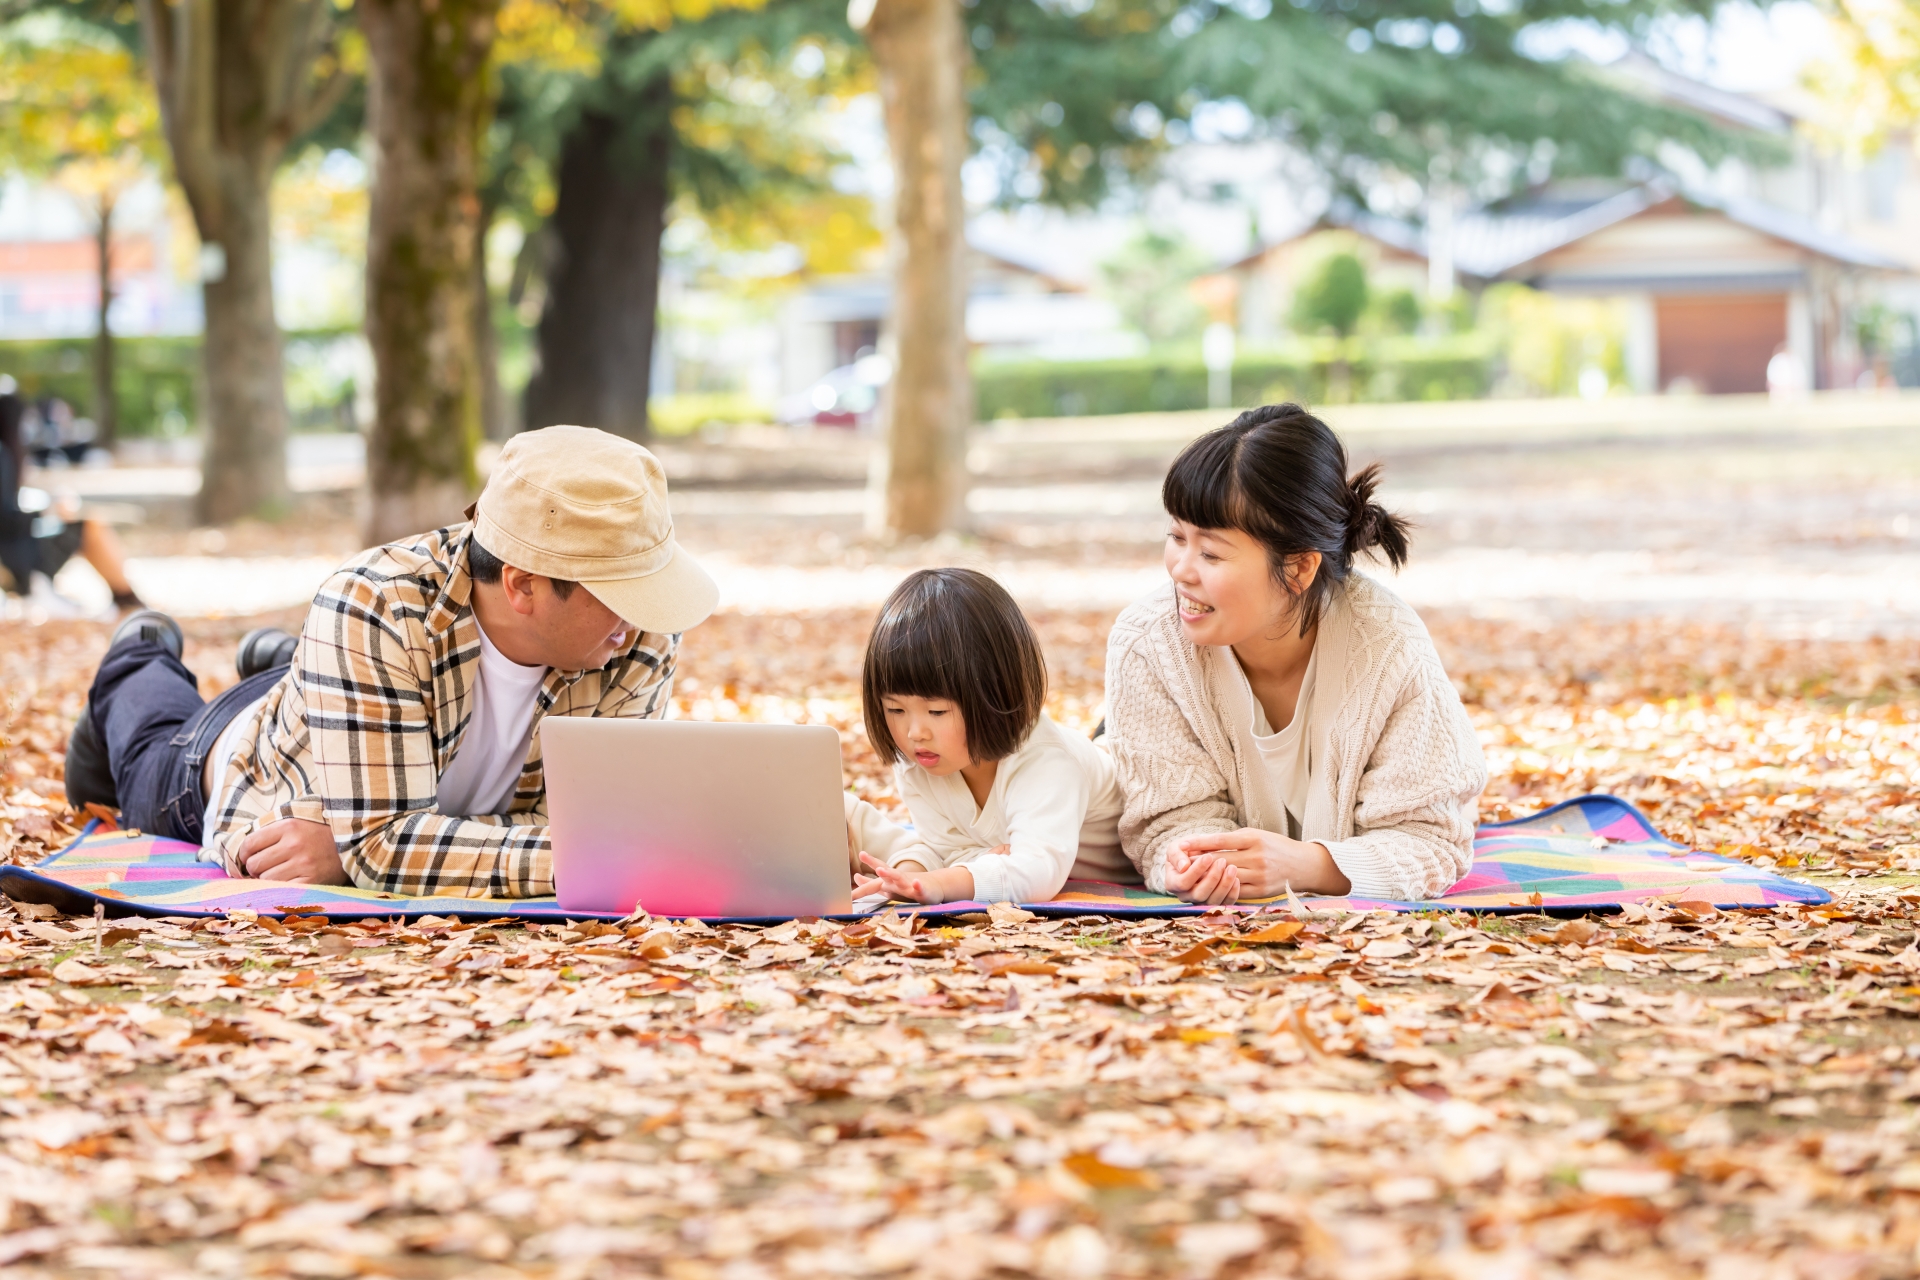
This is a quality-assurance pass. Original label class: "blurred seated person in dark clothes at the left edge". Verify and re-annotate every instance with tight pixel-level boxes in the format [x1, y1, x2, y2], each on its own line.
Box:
[0, 374, 144, 614]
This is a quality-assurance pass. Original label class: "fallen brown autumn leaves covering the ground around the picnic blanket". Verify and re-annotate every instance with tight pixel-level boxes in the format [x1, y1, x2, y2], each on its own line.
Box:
[0, 612, 1920, 1280]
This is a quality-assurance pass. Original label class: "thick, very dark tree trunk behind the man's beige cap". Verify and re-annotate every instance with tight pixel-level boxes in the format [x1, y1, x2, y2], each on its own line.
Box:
[526, 77, 672, 439]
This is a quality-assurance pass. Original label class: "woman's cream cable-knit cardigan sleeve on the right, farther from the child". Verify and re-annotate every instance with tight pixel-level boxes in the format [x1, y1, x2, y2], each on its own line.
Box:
[1327, 643, 1486, 900]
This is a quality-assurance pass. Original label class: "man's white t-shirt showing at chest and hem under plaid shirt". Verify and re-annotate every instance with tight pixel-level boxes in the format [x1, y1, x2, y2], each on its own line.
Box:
[200, 618, 547, 852]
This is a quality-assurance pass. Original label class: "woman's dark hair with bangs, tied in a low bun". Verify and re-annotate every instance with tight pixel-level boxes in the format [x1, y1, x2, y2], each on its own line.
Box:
[1160, 405, 1411, 635]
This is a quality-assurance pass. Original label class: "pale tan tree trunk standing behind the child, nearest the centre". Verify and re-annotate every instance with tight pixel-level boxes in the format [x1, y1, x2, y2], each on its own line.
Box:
[866, 0, 973, 537]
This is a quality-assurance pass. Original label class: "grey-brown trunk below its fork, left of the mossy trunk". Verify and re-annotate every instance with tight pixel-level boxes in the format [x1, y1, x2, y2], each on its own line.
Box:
[198, 163, 288, 524]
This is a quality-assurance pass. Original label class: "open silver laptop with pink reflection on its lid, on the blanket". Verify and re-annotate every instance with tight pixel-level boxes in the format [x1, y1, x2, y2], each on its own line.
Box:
[540, 716, 852, 915]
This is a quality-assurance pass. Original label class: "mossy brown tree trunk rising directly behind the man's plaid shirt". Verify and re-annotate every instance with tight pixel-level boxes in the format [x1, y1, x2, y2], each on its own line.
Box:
[355, 0, 497, 543]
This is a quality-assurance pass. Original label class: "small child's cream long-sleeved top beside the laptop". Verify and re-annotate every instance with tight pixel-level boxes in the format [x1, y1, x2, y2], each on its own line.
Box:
[847, 714, 1139, 902]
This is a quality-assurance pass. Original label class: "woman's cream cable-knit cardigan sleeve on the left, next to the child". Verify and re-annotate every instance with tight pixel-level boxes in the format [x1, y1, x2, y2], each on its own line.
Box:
[1106, 610, 1242, 892]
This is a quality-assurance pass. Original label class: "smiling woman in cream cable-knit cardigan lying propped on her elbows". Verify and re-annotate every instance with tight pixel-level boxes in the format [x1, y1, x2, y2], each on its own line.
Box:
[1106, 405, 1486, 902]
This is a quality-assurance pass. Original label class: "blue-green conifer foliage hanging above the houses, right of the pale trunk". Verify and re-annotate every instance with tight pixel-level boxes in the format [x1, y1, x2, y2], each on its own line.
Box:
[968, 0, 1758, 205]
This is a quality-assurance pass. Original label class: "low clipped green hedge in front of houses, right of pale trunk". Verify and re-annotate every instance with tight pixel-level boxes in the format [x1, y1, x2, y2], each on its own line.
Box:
[973, 336, 1494, 420]
